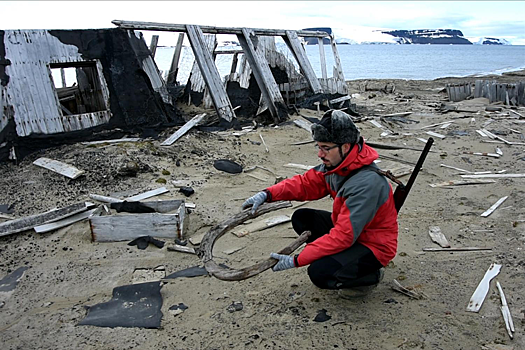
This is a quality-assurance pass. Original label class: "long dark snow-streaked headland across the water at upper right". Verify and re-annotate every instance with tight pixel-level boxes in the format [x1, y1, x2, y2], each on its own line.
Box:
[382, 29, 472, 45]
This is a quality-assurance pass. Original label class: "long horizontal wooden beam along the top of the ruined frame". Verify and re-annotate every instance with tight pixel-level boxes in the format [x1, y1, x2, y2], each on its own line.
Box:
[111, 20, 329, 38]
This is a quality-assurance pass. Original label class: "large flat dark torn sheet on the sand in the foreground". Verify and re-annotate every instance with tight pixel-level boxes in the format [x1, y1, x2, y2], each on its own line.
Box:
[79, 282, 162, 328]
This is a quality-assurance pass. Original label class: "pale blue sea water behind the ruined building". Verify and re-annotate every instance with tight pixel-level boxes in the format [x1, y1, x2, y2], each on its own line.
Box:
[155, 44, 525, 84]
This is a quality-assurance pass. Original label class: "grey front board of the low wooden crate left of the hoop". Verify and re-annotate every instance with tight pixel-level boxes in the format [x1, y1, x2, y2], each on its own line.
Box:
[89, 213, 179, 242]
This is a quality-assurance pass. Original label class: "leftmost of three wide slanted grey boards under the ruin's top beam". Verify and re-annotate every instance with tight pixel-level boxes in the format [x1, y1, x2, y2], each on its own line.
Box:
[186, 25, 235, 122]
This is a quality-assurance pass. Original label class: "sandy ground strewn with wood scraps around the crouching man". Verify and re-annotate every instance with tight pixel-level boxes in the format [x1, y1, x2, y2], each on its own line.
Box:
[0, 70, 525, 350]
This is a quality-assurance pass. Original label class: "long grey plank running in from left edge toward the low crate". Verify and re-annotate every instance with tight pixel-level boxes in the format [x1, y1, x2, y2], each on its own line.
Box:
[0, 202, 88, 237]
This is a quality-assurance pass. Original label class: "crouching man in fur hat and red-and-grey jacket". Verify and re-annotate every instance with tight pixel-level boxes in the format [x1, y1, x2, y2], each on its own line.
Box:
[242, 111, 398, 298]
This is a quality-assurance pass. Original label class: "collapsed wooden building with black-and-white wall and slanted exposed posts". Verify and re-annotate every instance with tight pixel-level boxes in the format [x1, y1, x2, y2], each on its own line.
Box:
[0, 21, 349, 160]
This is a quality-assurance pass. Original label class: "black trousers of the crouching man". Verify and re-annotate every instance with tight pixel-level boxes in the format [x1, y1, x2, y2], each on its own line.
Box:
[292, 208, 383, 289]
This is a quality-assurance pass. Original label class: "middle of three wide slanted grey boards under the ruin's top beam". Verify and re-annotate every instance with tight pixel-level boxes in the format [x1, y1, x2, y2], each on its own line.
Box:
[237, 28, 284, 123]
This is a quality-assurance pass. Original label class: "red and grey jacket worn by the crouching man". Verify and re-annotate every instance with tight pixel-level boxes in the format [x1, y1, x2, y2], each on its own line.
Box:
[266, 142, 398, 266]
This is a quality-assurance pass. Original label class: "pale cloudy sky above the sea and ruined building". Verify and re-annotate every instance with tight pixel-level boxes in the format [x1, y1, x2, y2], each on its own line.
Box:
[0, 0, 525, 46]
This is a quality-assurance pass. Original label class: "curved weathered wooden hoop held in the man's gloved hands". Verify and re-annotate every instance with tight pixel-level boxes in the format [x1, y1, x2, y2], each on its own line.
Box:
[197, 202, 310, 281]
